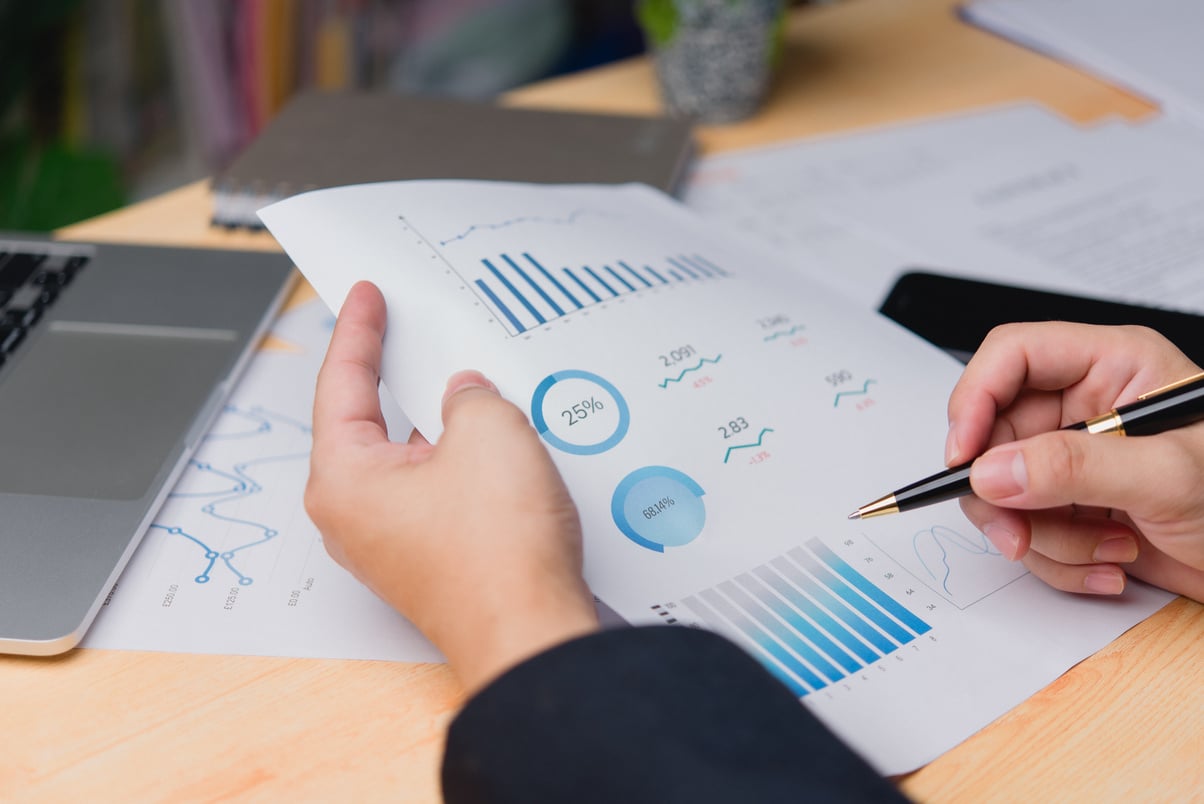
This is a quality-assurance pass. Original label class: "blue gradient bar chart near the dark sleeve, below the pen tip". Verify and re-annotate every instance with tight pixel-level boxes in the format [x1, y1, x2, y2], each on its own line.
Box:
[674, 539, 932, 698]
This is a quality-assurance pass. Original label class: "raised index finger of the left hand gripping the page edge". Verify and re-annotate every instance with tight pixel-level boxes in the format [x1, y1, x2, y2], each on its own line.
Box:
[313, 282, 388, 449]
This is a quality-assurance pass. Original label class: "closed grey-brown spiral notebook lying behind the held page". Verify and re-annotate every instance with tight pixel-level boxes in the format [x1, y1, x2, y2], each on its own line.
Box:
[212, 91, 692, 229]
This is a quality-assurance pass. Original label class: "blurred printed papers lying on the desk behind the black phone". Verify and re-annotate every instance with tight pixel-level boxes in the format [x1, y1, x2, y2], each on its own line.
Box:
[685, 106, 1204, 312]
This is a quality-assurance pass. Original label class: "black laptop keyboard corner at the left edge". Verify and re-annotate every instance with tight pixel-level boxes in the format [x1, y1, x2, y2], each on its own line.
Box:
[0, 249, 88, 366]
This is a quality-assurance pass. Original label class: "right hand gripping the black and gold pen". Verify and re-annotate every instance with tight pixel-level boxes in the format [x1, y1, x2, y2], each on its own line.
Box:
[945, 323, 1204, 601]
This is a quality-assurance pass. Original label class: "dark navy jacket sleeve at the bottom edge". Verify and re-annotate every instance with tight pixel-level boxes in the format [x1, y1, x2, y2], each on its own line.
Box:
[443, 626, 904, 804]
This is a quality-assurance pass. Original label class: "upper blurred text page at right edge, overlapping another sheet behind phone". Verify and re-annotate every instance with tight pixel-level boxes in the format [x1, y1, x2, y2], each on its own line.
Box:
[834, 114, 1204, 312]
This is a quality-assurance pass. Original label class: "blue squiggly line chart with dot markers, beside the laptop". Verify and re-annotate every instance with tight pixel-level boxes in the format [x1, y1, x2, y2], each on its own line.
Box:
[151, 406, 312, 586]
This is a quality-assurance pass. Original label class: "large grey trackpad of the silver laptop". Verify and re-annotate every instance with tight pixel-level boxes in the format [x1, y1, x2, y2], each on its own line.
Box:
[0, 325, 236, 499]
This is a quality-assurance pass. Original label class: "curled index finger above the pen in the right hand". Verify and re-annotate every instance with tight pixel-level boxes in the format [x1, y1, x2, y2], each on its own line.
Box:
[946, 321, 1191, 465]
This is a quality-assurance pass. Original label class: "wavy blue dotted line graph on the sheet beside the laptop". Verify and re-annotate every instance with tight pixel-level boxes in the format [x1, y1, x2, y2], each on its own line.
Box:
[151, 407, 312, 586]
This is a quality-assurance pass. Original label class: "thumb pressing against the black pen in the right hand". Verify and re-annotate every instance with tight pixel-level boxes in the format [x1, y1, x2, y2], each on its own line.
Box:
[970, 430, 1202, 521]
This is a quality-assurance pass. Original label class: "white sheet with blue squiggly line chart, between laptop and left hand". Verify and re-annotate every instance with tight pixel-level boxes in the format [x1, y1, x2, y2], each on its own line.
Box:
[83, 298, 442, 662]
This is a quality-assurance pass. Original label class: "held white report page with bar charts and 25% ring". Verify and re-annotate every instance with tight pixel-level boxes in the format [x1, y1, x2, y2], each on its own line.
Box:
[260, 182, 1170, 774]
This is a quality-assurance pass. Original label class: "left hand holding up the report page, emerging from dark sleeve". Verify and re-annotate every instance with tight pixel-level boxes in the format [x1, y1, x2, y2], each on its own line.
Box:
[305, 282, 597, 690]
